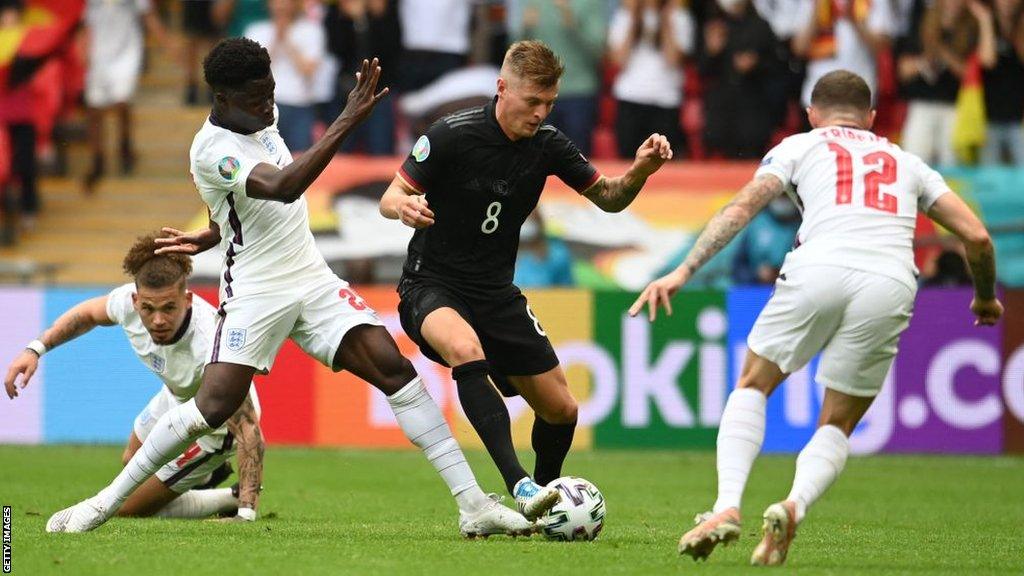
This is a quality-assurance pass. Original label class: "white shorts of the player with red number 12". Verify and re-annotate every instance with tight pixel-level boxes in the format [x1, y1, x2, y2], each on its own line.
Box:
[746, 265, 915, 397]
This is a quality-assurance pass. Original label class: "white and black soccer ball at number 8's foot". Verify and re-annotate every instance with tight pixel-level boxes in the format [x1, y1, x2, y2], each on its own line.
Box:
[541, 476, 605, 542]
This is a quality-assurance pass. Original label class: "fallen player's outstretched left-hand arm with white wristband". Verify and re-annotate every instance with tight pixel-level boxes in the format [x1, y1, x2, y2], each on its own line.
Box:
[3, 295, 114, 399]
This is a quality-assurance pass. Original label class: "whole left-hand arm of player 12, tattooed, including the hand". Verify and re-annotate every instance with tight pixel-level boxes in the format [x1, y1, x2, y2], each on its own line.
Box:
[630, 174, 785, 322]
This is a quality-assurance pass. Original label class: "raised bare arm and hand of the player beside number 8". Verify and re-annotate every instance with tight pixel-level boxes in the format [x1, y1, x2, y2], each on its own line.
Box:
[246, 58, 388, 204]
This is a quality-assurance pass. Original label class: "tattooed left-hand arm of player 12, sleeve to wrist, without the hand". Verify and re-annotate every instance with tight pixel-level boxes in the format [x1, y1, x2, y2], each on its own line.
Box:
[680, 174, 783, 275]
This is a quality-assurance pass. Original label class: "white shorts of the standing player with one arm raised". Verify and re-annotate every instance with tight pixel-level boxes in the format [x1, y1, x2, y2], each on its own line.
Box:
[210, 274, 383, 374]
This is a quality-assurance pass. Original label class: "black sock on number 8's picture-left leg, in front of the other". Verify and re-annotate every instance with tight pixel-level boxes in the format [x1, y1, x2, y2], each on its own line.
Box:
[452, 360, 529, 494]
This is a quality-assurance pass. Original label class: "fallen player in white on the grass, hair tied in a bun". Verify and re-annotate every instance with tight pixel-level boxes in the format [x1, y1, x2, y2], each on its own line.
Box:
[4, 235, 263, 520]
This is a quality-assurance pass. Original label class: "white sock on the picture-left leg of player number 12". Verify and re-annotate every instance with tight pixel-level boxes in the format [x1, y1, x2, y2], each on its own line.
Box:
[712, 388, 768, 513]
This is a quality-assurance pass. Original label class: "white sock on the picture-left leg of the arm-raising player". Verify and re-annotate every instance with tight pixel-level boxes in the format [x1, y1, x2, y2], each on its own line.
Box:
[98, 399, 212, 510]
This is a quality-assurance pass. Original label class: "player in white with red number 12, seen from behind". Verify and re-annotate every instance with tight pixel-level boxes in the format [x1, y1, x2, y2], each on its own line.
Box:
[630, 71, 1002, 565]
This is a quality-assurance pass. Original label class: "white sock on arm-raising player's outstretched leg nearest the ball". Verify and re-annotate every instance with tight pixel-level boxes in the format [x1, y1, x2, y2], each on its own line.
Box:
[387, 376, 490, 512]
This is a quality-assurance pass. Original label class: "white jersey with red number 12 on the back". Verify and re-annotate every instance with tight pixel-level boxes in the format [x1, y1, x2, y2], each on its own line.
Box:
[757, 126, 949, 290]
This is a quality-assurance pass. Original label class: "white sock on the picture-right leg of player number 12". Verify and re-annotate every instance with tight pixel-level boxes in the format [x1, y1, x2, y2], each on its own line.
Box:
[786, 424, 850, 522]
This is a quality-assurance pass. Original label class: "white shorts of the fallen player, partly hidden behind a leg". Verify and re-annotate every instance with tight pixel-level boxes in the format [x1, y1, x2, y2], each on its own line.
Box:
[133, 386, 234, 494]
